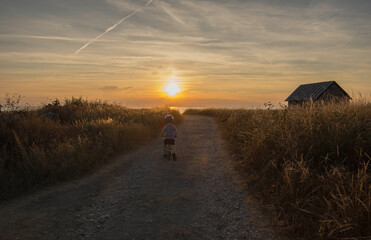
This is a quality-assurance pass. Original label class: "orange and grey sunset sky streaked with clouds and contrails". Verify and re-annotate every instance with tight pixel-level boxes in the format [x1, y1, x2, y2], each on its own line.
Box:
[0, 0, 371, 106]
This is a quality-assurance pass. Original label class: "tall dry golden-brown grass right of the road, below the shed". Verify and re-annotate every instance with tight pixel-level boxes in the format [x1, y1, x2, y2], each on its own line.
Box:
[185, 102, 371, 239]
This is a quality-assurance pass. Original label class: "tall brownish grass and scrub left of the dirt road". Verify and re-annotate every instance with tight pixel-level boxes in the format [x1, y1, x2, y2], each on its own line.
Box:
[0, 98, 182, 200]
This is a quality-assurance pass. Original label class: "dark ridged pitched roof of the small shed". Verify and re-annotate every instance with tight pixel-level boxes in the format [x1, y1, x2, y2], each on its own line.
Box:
[285, 81, 348, 101]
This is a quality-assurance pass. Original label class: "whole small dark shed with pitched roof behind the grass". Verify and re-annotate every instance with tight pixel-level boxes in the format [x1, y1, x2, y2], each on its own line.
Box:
[285, 81, 352, 107]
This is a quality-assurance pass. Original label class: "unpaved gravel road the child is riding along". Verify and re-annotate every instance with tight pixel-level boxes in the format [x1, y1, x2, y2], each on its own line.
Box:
[0, 116, 275, 239]
